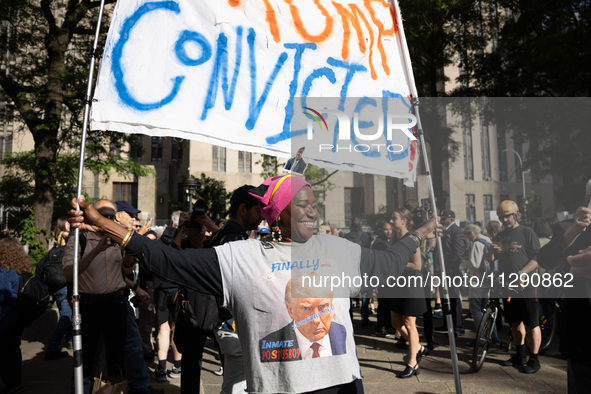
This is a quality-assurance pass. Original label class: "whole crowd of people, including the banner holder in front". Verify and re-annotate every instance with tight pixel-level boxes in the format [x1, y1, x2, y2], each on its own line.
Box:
[0, 174, 591, 393]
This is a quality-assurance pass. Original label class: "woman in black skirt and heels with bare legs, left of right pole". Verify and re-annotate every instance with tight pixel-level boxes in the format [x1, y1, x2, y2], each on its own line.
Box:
[390, 208, 428, 379]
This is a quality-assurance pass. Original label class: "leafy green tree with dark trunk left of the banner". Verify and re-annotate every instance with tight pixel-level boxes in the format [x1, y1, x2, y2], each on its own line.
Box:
[0, 0, 150, 243]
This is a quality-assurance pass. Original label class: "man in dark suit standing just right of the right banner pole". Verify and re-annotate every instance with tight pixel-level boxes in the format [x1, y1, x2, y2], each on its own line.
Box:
[436, 209, 468, 335]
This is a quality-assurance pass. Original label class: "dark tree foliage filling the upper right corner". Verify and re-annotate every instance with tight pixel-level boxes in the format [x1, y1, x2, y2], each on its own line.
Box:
[456, 0, 591, 210]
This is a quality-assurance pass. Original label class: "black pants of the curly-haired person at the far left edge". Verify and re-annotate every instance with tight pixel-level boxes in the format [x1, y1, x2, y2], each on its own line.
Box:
[0, 322, 24, 391]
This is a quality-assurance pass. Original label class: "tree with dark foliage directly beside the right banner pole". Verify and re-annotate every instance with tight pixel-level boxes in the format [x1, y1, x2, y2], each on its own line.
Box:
[400, 0, 481, 206]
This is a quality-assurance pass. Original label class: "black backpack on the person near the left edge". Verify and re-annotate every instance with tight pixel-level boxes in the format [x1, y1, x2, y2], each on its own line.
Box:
[16, 272, 49, 327]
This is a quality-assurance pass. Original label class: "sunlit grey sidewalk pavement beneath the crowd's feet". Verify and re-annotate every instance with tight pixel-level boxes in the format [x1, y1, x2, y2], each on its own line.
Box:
[0, 302, 567, 394]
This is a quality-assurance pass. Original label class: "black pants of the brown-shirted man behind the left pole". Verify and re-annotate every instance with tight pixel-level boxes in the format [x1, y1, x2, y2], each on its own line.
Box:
[80, 291, 128, 393]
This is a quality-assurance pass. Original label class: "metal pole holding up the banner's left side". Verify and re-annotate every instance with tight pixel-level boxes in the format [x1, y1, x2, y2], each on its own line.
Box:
[72, 0, 105, 394]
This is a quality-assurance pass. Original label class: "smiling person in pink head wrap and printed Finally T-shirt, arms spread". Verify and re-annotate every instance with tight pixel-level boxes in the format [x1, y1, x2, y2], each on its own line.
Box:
[70, 174, 441, 393]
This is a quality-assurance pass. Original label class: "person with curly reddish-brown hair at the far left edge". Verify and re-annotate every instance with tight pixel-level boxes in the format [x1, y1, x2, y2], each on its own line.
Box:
[0, 237, 33, 393]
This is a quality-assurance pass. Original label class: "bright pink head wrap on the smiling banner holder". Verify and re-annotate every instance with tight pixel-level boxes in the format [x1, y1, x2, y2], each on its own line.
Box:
[249, 174, 312, 225]
